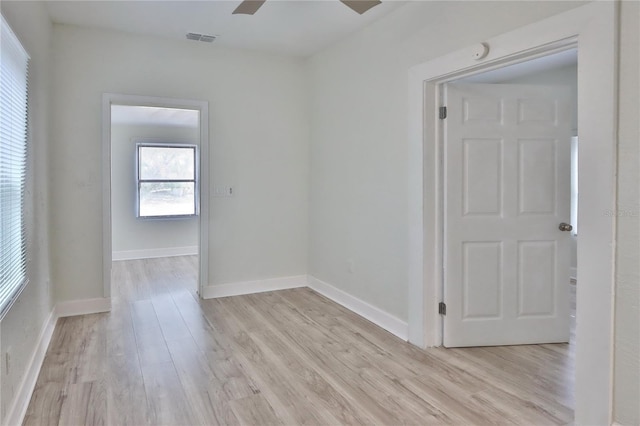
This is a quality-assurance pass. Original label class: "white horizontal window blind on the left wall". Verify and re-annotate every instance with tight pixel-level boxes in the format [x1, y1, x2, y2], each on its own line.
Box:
[0, 17, 29, 318]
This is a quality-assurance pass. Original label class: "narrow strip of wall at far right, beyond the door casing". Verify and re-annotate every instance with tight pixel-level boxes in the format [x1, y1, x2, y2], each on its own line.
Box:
[612, 1, 640, 425]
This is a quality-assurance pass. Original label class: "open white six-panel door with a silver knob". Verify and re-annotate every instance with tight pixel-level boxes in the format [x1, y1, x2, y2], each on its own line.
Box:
[443, 84, 571, 347]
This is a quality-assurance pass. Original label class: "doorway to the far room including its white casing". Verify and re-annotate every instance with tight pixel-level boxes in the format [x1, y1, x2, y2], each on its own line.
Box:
[103, 94, 209, 297]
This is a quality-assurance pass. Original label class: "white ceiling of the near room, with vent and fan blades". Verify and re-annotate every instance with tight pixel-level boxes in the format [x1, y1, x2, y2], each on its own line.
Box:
[46, 0, 405, 57]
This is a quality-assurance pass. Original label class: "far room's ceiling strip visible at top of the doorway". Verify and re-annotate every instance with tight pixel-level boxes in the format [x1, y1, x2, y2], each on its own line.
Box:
[111, 105, 200, 128]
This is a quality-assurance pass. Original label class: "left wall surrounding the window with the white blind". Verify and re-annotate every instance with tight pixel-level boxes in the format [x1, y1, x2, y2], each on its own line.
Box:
[0, 1, 53, 424]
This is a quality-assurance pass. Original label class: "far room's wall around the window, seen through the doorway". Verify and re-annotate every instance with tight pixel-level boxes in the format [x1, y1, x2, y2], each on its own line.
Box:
[111, 123, 200, 259]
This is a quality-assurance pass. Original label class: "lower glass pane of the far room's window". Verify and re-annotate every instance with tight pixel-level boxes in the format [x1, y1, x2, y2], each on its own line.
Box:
[140, 182, 196, 217]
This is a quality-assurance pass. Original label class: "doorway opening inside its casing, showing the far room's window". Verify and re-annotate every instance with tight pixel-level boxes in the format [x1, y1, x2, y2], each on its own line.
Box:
[111, 104, 200, 294]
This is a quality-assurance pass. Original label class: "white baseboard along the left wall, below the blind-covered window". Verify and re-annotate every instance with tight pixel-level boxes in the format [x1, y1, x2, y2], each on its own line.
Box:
[4, 308, 58, 425]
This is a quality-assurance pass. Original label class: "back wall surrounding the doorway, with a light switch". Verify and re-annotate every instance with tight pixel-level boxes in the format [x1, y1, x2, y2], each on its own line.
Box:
[50, 25, 309, 301]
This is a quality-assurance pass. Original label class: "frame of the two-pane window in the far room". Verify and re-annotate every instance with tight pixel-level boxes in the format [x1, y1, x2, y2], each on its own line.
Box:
[135, 141, 200, 220]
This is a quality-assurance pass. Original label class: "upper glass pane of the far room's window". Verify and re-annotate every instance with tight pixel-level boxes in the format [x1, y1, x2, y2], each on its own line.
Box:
[139, 146, 195, 180]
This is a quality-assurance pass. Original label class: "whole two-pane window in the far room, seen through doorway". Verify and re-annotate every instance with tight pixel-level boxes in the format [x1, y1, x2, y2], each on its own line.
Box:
[136, 143, 198, 218]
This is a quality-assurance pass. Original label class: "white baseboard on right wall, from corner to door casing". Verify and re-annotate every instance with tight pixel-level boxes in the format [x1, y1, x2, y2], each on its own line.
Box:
[309, 276, 409, 341]
